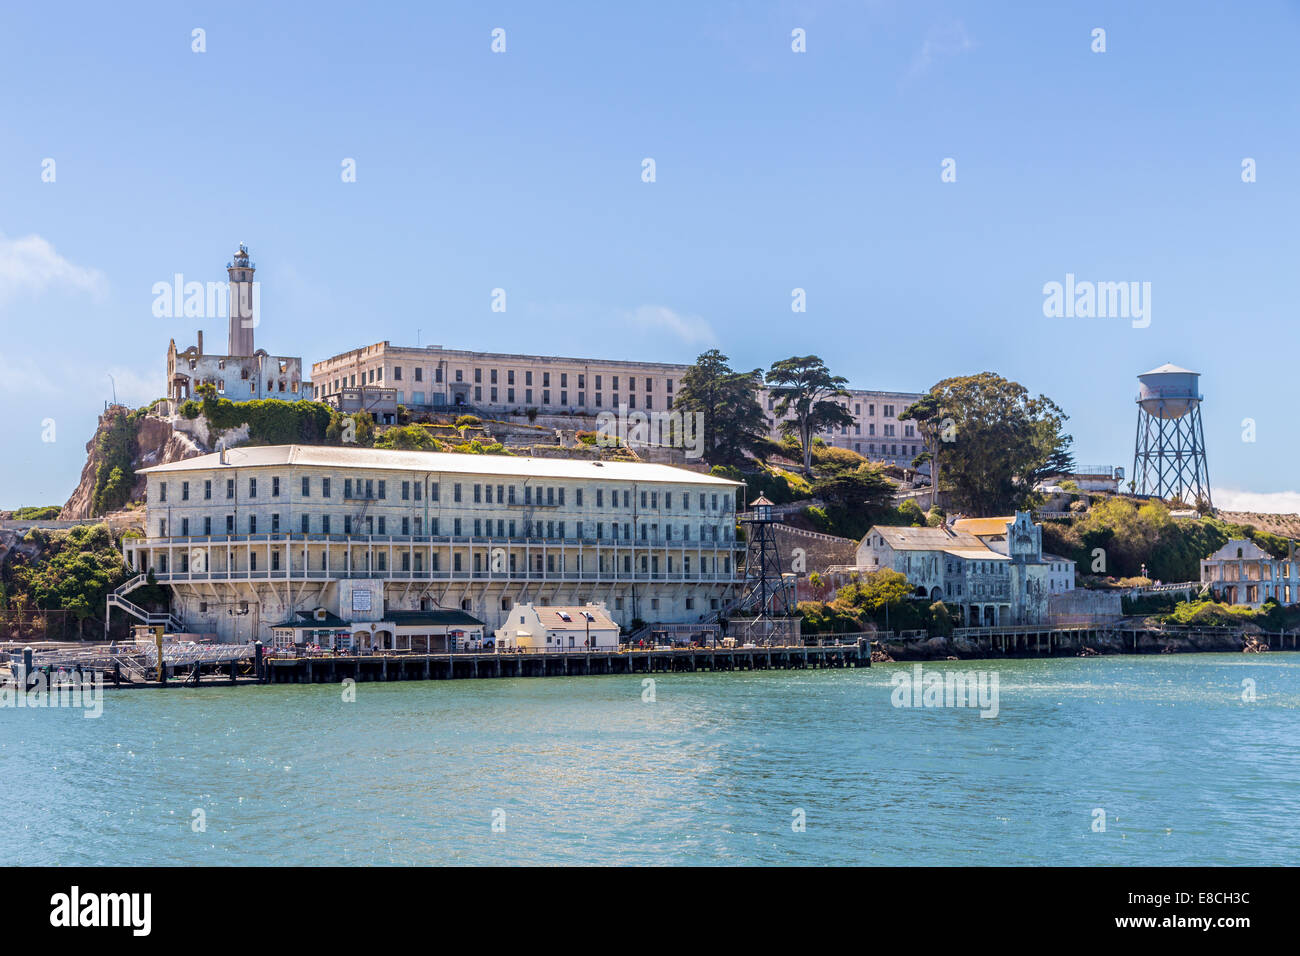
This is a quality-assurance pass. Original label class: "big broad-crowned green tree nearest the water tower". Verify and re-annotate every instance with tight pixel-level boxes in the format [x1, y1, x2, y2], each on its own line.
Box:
[930, 372, 1074, 515]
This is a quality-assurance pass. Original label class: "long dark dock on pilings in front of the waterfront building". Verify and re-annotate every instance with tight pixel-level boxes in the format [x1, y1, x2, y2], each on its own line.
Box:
[265, 643, 871, 684]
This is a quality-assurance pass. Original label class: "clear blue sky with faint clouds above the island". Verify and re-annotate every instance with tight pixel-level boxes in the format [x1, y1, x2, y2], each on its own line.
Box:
[0, 0, 1300, 510]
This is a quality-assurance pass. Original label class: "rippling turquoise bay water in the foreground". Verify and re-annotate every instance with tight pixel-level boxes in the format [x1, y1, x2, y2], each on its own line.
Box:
[0, 653, 1300, 865]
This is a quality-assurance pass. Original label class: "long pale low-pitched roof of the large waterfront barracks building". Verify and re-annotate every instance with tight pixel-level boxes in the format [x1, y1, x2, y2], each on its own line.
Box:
[137, 445, 744, 488]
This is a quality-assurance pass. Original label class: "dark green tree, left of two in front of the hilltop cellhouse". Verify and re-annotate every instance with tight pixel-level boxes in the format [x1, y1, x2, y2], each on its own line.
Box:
[672, 349, 767, 464]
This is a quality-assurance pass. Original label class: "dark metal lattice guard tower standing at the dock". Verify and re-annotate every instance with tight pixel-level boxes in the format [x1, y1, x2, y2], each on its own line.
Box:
[732, 496, 800, 644]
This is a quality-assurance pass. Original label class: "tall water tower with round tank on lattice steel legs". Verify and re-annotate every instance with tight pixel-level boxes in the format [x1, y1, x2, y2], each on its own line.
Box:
[1132, 364, 1212, 507]
